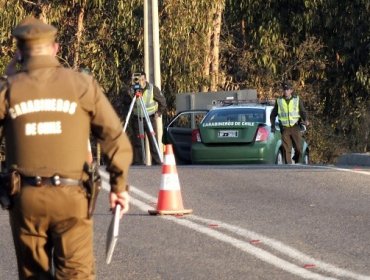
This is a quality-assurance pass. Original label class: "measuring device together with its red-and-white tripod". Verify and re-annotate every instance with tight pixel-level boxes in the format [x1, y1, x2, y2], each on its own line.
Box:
[123, 73, 163, 164]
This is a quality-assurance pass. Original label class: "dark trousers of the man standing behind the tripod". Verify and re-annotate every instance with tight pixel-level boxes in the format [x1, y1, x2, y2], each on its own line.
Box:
[131, 115, 161, 165]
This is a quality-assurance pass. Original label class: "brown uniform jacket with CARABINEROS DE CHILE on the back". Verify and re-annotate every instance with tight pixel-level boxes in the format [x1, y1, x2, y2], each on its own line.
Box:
[0, 56, 132, 192]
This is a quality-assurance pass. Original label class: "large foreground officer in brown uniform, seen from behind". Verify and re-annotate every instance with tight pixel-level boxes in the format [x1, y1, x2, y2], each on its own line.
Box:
[0, 17, 132, 279]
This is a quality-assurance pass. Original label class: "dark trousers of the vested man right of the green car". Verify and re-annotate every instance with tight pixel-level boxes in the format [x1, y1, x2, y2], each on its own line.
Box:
[281, 125, 303, 164]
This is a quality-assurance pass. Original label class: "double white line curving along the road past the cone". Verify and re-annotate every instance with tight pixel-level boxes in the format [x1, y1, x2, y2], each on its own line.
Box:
[101, 168, 370, 280]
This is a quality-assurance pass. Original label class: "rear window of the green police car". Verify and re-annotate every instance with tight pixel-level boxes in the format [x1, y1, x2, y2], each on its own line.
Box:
[203, 108, 265, 123]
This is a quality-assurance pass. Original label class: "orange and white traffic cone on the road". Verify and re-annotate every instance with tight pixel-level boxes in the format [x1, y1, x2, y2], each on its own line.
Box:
[148, 145, 193, 215]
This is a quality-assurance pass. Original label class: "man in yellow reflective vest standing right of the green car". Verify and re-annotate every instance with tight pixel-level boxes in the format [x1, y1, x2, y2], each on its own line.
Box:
[270, 82, 309, 164]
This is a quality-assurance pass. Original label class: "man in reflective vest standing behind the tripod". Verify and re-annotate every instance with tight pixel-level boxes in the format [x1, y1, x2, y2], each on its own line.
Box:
[130, 72, 167, 165]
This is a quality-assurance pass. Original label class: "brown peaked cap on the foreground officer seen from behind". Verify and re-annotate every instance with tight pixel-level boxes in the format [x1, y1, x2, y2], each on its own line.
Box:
[12, 16, 57, 46]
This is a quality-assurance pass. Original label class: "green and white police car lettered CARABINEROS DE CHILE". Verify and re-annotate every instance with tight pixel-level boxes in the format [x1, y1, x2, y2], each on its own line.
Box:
[191, 103, 309, 164]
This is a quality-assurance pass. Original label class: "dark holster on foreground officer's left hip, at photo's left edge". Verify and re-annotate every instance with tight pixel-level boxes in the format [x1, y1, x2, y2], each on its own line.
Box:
[0, 170, 21, 210]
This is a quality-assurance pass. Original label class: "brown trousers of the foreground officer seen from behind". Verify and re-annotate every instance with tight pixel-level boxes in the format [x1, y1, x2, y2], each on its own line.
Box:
[10, 186, 95, 280]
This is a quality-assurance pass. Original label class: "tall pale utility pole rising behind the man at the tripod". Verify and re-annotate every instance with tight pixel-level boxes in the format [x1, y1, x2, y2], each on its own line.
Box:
[144, 0, 163, 165]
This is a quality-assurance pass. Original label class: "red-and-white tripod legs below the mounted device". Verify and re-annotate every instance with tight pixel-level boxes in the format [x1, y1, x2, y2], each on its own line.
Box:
[123, 90, 163, 162]
